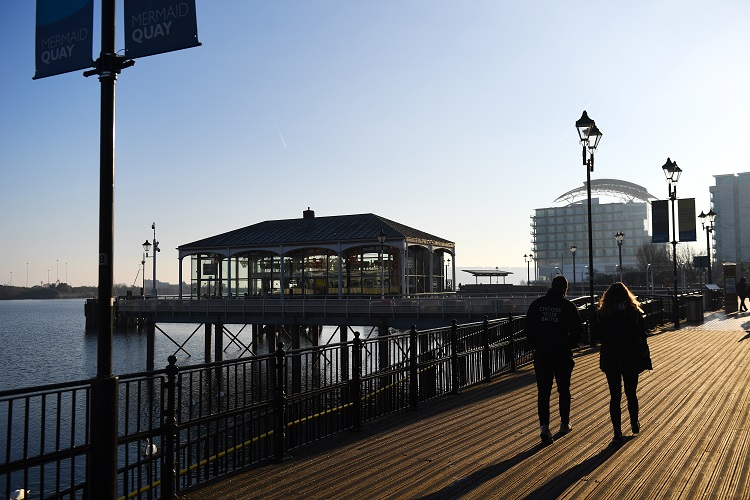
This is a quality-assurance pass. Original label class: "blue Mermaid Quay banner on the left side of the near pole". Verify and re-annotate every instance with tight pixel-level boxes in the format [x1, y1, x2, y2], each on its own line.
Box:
[34, 0, 94, 80]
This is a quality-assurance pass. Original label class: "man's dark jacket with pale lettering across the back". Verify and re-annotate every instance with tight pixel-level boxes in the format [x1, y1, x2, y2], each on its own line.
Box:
[524, 288, 583, 355]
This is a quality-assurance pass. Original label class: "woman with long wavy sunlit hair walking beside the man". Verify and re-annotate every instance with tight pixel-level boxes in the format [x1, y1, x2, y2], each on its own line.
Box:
[596, 282, 652, 444]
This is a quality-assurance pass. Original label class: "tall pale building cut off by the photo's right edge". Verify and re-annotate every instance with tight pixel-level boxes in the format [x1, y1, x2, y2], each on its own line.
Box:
[712, 172, 750, 274]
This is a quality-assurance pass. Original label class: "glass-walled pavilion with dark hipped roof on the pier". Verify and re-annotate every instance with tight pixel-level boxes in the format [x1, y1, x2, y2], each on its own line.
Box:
[177, 208, 455, 298]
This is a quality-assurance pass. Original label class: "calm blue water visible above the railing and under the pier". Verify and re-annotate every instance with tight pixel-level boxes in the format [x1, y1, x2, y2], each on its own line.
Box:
[0, 299, 344, 391]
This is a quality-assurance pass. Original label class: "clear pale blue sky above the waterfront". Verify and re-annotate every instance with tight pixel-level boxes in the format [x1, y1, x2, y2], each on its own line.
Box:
[0, 0, 750, 286]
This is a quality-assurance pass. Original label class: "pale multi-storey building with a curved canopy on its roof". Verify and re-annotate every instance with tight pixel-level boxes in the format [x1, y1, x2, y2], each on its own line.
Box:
[531, 179, 656, 282]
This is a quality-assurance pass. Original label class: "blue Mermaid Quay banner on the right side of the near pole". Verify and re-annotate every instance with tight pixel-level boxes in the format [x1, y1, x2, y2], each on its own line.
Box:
[125, 0, 200, 59]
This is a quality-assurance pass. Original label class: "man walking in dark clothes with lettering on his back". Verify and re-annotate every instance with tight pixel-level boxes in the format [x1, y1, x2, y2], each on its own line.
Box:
[524, 276, 583, 444]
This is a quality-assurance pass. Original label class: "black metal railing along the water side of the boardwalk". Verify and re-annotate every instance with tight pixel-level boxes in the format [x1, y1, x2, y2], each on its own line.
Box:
[0, 296, 716, 499]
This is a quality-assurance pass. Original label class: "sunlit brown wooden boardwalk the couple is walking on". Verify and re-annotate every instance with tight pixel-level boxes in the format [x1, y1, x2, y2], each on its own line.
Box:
[185, 312, 750, 500]
